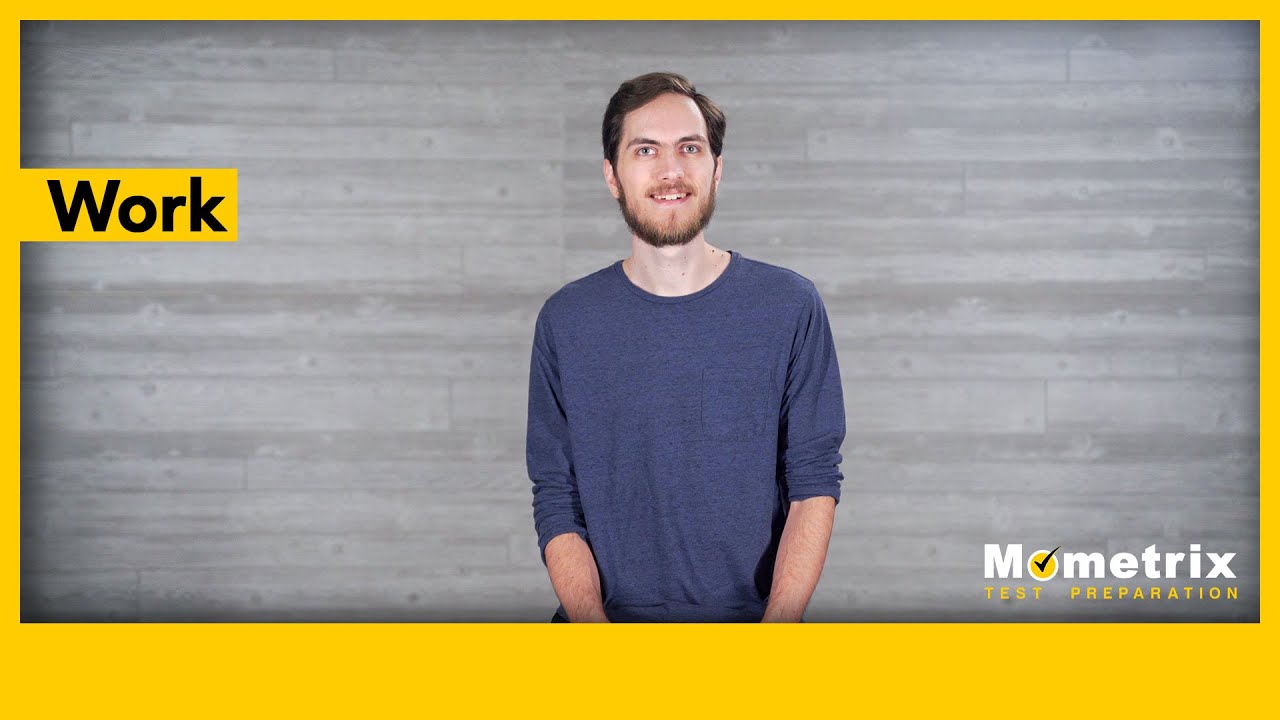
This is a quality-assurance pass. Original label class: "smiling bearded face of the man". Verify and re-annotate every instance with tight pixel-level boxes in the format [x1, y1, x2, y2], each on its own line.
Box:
[604, 94, 721, 247]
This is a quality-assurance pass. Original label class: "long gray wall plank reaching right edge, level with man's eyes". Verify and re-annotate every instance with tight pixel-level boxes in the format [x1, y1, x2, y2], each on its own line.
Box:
[803, 127, 1258, 163]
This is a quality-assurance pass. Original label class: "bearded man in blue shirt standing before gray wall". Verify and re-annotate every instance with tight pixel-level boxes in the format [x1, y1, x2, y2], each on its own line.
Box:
[526, 73, 845, 623]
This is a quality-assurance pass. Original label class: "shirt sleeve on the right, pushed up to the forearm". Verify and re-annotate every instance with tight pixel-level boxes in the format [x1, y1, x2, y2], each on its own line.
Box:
[778, 284, 845, 503]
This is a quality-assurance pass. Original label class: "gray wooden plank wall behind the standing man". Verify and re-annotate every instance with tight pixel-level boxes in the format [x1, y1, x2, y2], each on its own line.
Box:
[22, 23, 1258, 621]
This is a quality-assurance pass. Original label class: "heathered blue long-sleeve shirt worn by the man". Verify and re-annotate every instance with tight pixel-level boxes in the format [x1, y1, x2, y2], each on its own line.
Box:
[526, 252, 845, 621]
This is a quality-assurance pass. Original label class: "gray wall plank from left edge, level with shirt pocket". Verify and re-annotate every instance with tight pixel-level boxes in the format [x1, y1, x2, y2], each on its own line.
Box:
[23, 378, 449, 430]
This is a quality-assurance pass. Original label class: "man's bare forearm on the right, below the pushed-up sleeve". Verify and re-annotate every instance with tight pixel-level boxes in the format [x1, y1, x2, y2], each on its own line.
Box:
[760, 496, 836, 623]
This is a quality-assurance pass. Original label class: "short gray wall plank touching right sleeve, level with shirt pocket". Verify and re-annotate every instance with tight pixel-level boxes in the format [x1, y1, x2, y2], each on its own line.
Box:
[844, 379, 1044, 434]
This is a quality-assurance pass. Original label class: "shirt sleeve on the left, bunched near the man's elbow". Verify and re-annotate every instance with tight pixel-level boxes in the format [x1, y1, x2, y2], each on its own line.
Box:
[525, 299, 588, 565]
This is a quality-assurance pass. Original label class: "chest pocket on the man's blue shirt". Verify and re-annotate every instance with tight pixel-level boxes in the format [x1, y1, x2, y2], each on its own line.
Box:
[703, 368, 771, 439]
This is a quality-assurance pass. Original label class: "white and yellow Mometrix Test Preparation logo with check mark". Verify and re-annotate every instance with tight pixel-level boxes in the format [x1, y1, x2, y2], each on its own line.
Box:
[983, 543, 1238, 600]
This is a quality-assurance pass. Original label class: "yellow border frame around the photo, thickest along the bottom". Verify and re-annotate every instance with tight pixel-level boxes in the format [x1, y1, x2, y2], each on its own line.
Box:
[0, 7, 1276, 717]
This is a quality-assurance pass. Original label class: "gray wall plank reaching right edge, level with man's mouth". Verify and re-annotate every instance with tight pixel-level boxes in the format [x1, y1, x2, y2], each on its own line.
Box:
[964, 160, 1258, 217]
